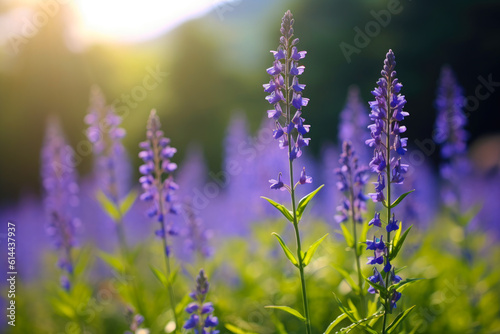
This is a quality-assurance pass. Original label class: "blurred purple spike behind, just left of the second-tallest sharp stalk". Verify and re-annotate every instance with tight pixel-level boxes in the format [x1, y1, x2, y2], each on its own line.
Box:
[339, 85, 370, 163]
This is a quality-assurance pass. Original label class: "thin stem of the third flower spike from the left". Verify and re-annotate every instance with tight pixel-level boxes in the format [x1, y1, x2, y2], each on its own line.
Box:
[152, 138, 179, 333]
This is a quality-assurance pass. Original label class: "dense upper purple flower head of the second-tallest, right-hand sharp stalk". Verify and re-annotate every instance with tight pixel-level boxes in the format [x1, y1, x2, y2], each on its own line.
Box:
[366, 50, 409, 232]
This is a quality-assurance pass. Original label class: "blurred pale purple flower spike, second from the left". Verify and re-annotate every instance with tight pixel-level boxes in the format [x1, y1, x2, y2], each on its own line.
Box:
[85, 86, 130, 202]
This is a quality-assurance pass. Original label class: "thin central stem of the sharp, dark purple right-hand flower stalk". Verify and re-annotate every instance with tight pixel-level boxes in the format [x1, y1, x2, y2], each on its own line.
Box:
[382, 78, 392, 334]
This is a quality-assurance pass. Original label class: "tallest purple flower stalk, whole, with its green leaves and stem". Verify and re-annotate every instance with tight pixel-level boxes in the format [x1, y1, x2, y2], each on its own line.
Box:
[263, 11, 326, 334]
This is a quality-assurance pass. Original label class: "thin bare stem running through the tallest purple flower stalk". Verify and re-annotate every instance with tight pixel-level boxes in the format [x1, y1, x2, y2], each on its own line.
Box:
[285, 45, 311, 334]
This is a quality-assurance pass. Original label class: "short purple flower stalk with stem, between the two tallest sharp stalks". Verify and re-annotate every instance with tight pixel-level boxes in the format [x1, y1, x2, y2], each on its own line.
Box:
[335, 141, 368, 314]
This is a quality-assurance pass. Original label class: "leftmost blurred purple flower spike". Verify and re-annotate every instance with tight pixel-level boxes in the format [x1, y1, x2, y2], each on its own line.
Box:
[41, 119, 80, 290]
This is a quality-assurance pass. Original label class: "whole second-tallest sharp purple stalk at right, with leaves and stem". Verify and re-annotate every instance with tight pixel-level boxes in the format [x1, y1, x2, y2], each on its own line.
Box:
[366, 50, 411, 334]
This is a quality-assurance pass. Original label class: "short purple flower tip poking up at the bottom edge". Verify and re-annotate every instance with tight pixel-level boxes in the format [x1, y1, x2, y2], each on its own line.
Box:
[183, 269, 220, 334]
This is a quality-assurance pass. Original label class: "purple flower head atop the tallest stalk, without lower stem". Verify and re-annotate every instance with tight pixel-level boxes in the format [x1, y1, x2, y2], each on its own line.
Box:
[263, 11, 310, 160]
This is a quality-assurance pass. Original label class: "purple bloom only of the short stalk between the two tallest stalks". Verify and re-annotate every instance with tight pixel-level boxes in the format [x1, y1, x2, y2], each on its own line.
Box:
[335, 141, 368, 223]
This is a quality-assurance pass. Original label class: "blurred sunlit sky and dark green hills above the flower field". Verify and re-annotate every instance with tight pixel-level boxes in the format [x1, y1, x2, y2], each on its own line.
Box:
[0, 0, 500, 204]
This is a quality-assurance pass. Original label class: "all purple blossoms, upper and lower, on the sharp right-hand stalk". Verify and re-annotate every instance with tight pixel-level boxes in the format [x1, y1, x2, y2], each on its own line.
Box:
[365, 50, 409, 307]
